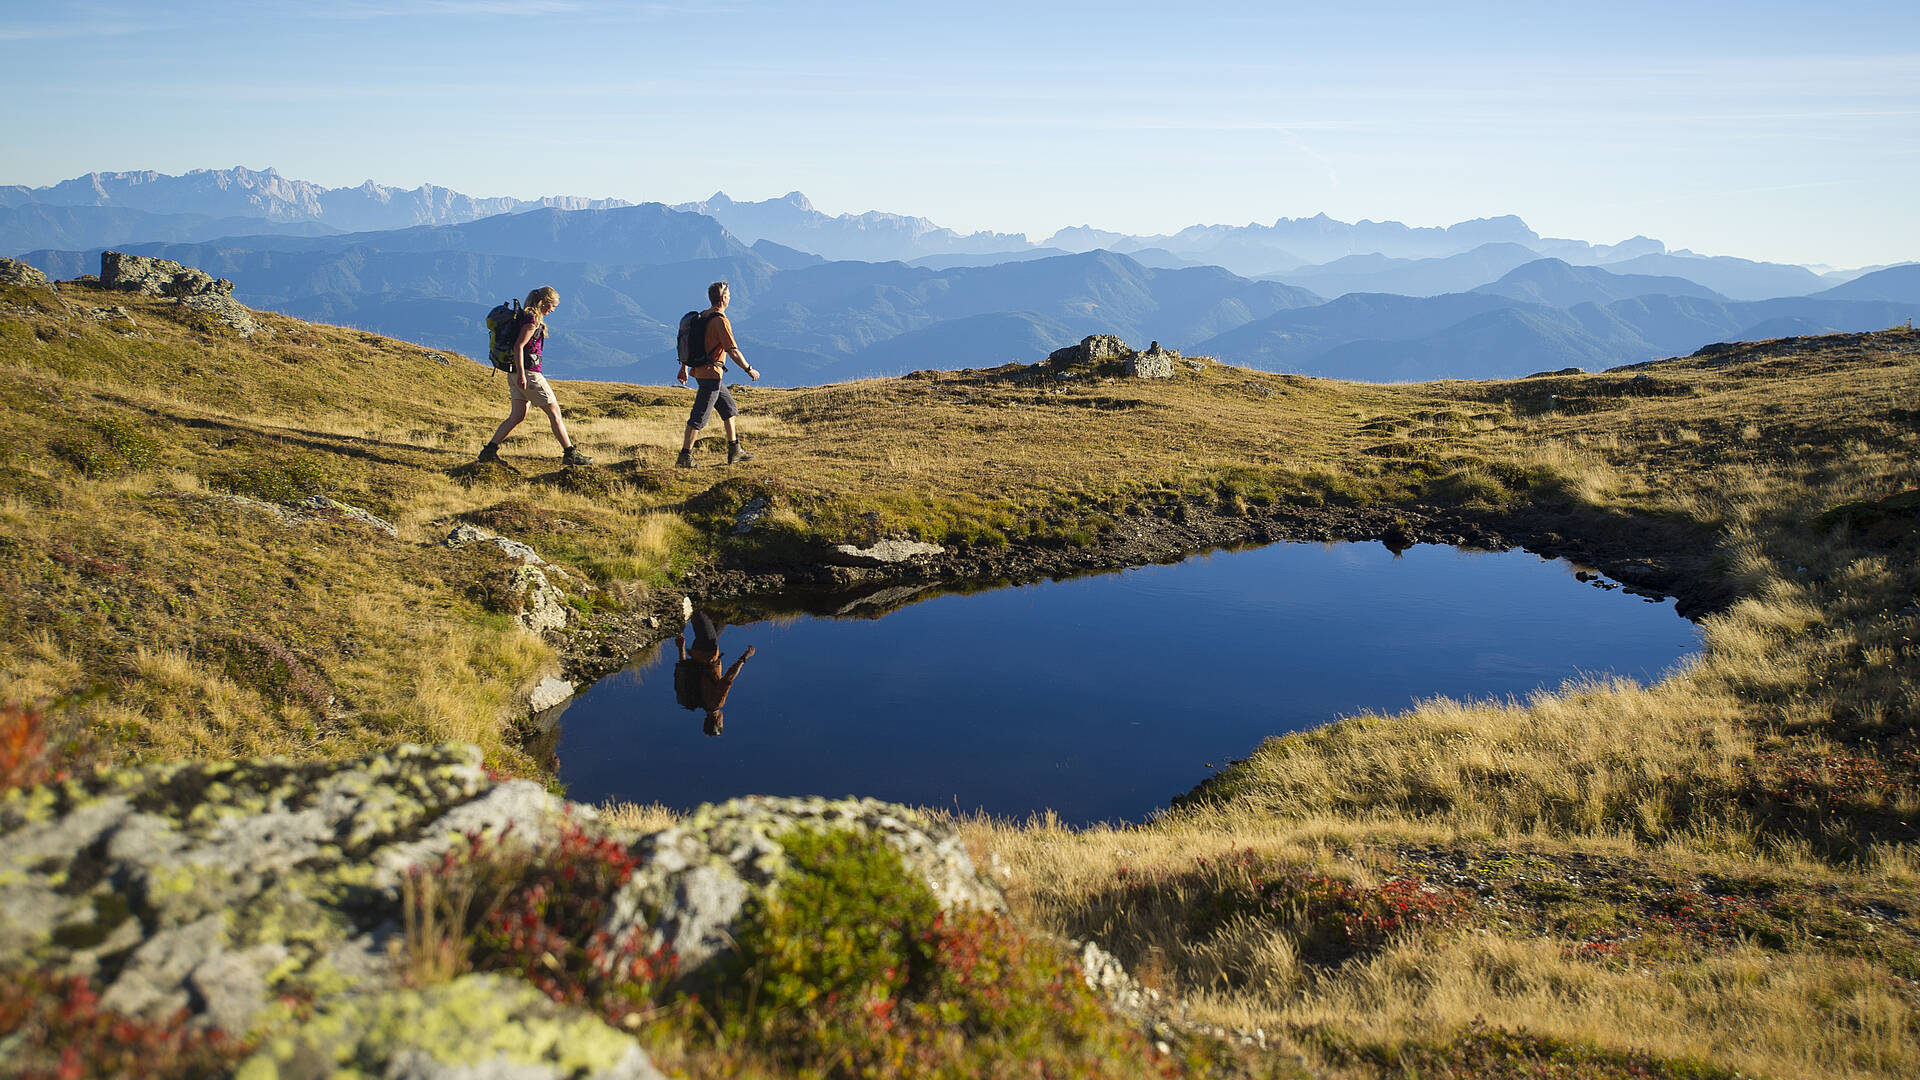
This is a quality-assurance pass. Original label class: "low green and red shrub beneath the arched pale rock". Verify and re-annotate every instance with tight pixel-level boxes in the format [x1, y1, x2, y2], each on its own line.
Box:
[714, 830, 1183, 1080]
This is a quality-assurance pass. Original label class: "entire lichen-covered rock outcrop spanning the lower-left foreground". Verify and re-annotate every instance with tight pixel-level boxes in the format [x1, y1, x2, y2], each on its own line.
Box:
[0, 746, 1004, 1080]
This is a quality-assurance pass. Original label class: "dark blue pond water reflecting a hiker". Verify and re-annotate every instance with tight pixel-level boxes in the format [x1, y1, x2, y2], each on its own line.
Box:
[559, 544, 1699, 822]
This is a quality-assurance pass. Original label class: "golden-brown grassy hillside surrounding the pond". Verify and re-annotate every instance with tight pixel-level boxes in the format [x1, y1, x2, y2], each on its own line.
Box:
[0, 278, 1920, 1076]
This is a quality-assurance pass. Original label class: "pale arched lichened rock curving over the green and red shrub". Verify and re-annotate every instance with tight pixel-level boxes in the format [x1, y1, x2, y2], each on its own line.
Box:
[605, 796, 1006, 978]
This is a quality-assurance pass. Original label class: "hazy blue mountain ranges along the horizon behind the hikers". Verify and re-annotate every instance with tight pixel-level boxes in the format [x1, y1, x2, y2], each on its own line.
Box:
[0, 169, 1920, 384]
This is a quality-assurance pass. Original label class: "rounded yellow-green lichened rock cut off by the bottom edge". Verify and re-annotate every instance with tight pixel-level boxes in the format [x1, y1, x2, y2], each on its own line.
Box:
[234, 974, 664, 1080]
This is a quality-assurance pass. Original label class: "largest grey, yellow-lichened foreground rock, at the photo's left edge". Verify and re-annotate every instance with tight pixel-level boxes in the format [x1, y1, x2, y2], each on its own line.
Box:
[0, 746, 568, 1026]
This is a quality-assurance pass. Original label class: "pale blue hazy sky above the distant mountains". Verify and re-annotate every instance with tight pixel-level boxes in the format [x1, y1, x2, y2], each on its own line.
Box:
[0, 0, 1920, 265]
